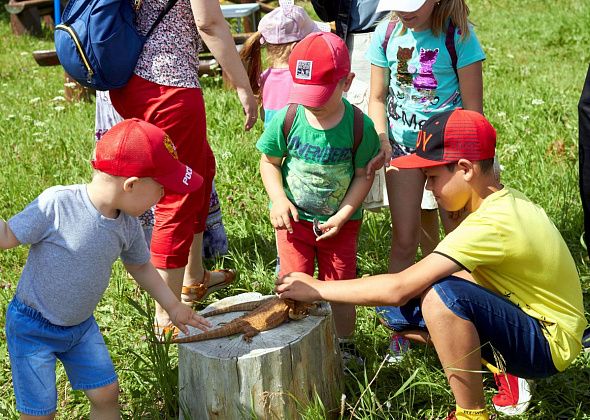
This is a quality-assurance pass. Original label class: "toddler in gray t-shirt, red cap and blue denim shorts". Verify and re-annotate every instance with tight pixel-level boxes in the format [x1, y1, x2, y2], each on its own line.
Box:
[0, 119, 209, 419]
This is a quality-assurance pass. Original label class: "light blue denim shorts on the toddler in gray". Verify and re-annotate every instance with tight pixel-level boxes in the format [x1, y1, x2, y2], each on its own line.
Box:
[6, 298, 117, 416]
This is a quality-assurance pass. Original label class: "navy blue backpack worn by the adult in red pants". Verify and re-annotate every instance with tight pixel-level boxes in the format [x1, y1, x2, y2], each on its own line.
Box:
[54, 0, 177, 90]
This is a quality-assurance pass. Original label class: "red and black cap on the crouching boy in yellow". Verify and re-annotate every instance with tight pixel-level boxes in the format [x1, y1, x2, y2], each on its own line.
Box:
[391, 108, 496, 169]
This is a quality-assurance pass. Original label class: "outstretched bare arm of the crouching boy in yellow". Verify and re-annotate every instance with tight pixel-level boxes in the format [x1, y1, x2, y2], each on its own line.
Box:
[275, 253, 461, 306]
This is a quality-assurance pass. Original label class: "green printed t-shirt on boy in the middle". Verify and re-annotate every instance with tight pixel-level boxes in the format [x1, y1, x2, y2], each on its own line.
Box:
[256, 99, 379, 222]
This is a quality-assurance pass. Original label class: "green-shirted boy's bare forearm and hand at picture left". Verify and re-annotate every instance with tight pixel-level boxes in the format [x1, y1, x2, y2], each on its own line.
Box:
[260, 154, 299, 233]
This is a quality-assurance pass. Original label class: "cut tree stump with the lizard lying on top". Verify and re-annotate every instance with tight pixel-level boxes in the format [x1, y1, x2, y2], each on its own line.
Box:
[178, 293, 343, 420]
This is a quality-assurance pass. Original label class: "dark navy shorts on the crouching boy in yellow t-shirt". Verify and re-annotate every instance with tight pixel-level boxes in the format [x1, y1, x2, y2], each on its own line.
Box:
[375, 276, 557, 378]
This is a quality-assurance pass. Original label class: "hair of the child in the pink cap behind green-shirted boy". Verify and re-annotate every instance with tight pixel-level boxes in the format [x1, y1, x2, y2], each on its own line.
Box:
[240, 32, 296, 95]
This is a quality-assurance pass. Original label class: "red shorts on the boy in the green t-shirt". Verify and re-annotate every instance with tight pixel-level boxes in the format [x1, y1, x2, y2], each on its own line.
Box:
[276, 220, 361, 280]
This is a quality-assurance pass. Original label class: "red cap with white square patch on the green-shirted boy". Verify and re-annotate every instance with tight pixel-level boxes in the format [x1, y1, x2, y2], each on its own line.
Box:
[289, 32, 350, 107]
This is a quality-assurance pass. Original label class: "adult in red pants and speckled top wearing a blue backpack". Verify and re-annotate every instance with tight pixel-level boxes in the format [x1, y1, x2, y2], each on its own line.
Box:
[110, 0, 257, 332]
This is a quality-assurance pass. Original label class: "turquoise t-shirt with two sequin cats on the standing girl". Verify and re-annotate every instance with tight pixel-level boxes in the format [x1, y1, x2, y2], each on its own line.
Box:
[367, 21, 485, 148]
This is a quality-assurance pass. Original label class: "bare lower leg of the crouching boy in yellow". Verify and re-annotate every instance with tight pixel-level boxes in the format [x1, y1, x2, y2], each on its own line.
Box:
[422, 288, 485, 409]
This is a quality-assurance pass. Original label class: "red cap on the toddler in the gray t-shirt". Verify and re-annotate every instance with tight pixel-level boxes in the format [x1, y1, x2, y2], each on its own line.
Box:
[91, 118, 203, 193]
